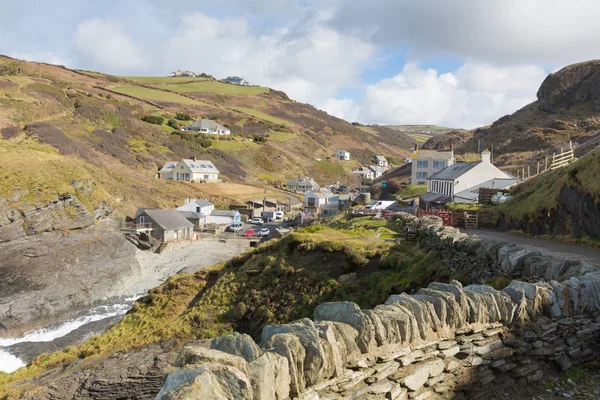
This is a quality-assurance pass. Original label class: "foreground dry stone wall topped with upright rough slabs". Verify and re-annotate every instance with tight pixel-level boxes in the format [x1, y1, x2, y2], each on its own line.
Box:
[157, 216, 600, 400]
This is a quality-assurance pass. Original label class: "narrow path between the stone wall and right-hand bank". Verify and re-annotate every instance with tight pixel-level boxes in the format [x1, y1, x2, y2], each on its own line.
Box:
[461, 229, 600, 265]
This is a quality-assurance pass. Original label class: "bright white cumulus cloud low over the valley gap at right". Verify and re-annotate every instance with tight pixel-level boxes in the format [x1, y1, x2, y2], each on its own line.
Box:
[347, 62, 546, 128]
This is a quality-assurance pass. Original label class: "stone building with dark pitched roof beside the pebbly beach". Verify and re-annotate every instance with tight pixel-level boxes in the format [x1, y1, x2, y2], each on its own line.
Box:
[135, 208, 194, 242]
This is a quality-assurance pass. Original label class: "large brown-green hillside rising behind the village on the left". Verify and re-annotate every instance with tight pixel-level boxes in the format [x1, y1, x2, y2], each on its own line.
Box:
[0, 56, 413, 211]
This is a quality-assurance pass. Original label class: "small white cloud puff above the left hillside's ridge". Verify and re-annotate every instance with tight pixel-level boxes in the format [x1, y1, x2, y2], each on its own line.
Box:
[73, 19, 151, 73]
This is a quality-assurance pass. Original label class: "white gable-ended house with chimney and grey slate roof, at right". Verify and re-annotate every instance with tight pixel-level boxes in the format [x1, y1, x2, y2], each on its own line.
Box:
[421, 150, 517, 203]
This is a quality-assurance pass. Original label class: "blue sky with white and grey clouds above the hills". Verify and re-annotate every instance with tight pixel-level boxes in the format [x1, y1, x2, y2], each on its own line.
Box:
[0, 0, 600, 129]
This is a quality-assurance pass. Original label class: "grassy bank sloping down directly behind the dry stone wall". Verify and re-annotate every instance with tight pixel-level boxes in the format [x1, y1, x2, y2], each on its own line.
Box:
[0, 217, 467, 396]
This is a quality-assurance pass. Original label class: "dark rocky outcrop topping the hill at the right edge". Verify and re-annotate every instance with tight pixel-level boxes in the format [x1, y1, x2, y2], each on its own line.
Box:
[537, 60, 600, 112]
